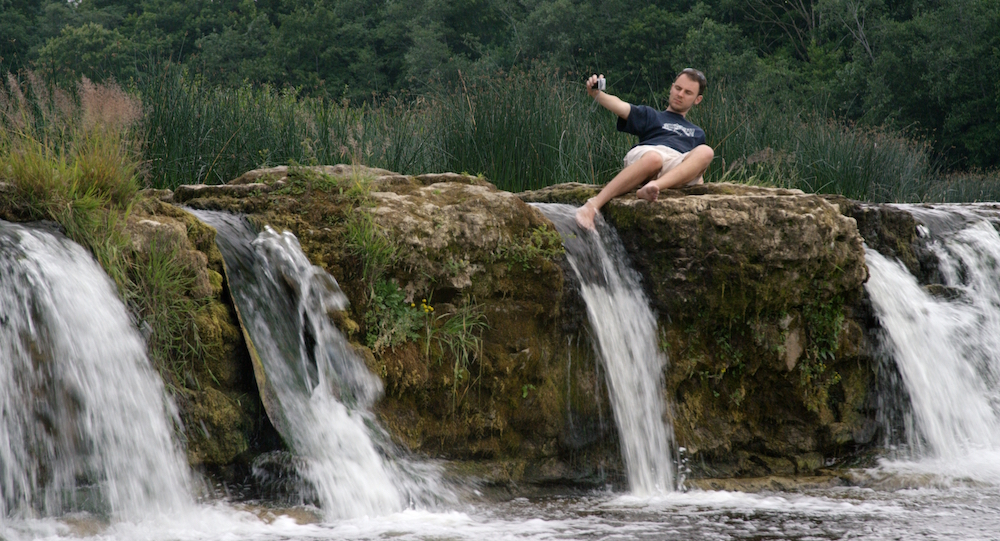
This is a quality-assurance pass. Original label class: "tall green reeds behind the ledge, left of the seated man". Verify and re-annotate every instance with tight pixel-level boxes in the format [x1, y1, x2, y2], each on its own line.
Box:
[136, 68, 627, 191]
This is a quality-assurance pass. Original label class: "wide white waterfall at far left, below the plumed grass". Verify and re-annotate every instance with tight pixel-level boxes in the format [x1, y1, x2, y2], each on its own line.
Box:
[0, 221, 193, 519]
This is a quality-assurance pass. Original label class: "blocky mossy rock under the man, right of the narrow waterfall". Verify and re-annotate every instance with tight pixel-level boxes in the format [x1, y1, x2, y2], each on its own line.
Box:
[522, 184, 875, 477]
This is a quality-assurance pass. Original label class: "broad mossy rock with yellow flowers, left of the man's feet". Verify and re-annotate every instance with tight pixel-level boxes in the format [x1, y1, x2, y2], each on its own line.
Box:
[177, 166, 619, 482]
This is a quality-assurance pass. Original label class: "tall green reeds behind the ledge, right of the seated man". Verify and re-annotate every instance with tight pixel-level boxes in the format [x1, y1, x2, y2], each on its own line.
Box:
[691, 84, 939, 203]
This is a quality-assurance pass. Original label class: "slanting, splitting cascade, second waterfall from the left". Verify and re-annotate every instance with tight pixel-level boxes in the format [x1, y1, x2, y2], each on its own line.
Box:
[193, 211, 450, 518]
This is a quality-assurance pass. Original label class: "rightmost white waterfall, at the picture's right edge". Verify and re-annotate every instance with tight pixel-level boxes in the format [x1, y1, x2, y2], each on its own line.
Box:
[866, 205, 1000, 462]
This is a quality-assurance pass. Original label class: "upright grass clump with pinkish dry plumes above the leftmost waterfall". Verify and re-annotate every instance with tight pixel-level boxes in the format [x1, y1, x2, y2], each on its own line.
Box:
[0, 72, 142, 215]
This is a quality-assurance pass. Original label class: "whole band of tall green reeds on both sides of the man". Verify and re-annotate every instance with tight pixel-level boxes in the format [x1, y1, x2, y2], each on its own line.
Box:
[137, 67, 995, 202]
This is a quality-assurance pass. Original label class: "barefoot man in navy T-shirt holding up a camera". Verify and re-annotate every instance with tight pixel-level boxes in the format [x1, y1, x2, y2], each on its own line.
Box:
[576, 68, 715, 229]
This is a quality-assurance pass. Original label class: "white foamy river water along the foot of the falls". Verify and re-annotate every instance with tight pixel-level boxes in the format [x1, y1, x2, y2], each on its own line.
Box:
[0, 489, 936, 541]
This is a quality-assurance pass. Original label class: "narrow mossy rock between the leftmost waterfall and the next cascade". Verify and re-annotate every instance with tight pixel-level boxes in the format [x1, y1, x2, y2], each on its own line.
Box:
[126, 191, 273, 468]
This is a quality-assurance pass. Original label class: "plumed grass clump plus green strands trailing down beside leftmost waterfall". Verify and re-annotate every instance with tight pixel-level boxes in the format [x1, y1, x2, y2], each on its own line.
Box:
[0, 74, 201, 388]
